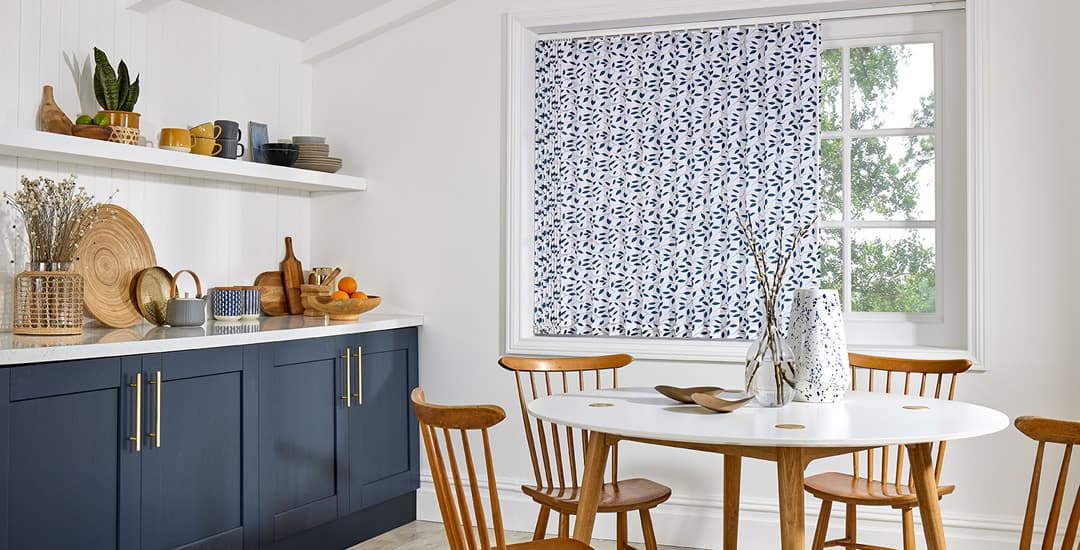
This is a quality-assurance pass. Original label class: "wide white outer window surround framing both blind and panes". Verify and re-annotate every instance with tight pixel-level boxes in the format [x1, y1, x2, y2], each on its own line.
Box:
[502, 0, 989, 367]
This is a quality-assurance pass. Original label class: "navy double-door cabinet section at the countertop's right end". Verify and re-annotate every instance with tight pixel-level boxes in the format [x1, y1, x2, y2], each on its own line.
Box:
[259, 328, 419, 544]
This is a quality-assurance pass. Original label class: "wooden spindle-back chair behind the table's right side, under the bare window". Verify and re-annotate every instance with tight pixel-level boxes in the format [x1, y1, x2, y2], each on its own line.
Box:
[805, 353, 971, 550]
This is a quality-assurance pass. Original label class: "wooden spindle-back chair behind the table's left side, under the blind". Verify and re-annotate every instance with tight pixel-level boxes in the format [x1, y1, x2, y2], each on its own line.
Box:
[499, 354, 672, 550]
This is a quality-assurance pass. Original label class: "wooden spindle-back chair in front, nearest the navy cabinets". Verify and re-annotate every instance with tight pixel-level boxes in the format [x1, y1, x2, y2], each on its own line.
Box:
[413, 388, 591, 550]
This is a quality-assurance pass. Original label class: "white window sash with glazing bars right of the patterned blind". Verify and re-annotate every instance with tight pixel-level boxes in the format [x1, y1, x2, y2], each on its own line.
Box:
[821, 13, 972, 357]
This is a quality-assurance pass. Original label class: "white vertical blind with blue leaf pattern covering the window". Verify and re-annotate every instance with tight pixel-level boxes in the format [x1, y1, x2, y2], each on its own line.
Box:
[534, 22, 821, 339]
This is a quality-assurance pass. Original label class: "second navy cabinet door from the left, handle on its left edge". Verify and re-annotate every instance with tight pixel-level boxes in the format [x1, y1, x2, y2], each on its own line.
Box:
[141, 347, 257, 550]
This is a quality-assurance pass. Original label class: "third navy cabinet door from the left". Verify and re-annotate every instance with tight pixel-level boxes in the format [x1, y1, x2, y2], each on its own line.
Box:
[259, 337, 346, 544]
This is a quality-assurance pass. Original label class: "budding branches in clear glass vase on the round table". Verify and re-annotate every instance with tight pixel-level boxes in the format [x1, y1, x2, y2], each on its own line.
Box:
[735, 209, 818, 405]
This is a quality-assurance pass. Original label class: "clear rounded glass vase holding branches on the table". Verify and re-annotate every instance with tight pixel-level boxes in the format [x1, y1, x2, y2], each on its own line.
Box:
[745, 322, 795, 407]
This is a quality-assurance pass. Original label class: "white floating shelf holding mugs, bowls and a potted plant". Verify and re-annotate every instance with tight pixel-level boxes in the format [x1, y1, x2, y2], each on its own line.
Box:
[0, 129, 367, 191]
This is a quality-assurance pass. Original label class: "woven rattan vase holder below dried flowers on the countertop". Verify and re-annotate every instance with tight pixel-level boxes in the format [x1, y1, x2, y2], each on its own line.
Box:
[12, 265, 82, 336]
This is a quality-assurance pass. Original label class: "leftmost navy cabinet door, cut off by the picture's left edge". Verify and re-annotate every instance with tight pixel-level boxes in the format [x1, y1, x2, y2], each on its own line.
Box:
[0, 357, 139, 550]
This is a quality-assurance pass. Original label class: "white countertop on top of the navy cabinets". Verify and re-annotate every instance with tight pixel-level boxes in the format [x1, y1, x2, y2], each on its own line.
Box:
[0, 313, 423, 365]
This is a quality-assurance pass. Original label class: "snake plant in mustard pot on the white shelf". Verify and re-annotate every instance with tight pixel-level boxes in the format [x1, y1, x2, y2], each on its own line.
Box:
[94, 48, 140, 145]
